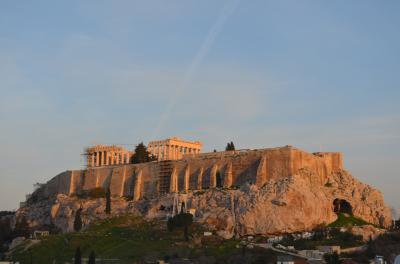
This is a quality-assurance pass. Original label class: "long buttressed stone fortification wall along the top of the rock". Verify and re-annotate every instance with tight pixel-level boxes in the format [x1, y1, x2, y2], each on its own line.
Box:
[39, 146, 343, 200]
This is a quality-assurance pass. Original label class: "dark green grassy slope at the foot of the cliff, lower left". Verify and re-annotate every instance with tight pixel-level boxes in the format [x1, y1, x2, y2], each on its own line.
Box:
[12, 216, 278, 264]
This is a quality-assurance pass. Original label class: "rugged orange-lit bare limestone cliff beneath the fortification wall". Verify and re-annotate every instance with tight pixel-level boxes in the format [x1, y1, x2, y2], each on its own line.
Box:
[17, 169, 391, 238]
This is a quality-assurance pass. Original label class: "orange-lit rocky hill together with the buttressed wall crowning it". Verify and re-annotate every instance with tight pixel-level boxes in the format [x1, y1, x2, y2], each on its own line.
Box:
[18, 139, 391, 238]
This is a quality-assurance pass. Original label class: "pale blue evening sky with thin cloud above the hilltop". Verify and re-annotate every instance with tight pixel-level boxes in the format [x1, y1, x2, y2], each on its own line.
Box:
[0, 0, 400, 210]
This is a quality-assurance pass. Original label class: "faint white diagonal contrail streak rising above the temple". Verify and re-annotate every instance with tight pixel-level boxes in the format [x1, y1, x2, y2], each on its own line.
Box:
[151, 0, 240, 139]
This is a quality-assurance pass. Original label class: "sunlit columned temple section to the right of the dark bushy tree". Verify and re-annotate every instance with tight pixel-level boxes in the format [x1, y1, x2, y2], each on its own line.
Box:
[148, 137, 202, 161]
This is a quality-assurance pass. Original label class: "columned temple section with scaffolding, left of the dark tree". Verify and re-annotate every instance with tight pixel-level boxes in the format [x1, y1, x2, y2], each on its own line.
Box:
[85, 145, 133, 167]
